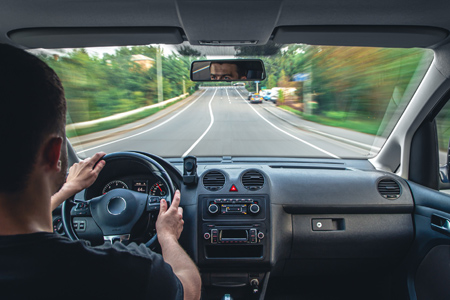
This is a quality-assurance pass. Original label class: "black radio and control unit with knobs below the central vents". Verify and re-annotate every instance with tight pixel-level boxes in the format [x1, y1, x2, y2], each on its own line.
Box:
[198, 193, 270, 265]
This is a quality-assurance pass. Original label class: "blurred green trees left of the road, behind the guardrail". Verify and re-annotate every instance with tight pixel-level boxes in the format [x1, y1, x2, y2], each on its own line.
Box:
[40, 46, 198, 124]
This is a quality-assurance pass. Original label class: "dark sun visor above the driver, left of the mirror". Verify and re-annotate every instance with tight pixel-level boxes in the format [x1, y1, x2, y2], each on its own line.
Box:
[8, 27, 183, 48]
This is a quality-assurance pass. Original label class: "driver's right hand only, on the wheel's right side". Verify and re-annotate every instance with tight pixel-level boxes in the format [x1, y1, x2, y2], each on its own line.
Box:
[156, 190, 184, 244]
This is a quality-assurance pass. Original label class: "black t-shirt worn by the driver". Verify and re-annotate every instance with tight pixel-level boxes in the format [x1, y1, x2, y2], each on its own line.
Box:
[0, 232, 183, 300]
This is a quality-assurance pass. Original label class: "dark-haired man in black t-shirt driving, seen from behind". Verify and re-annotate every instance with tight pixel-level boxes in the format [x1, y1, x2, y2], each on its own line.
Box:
[0, 44, 201, 299]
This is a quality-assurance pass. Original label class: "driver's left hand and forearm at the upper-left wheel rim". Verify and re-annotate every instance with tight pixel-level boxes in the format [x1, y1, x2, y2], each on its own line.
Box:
[51, 152, 106, 211]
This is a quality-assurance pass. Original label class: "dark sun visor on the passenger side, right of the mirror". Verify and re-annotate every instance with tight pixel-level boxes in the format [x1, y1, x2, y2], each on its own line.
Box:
[273, 26, 449, 48]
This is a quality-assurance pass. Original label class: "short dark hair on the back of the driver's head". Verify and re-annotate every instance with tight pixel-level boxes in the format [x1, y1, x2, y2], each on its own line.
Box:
[0, 44, 66, 192]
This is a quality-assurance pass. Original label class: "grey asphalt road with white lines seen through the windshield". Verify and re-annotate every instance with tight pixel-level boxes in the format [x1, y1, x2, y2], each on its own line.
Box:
[75, 87, 368, 158]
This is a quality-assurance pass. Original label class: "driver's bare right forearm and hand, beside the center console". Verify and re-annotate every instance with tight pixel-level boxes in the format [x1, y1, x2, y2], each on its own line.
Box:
[156, 191, 202, 300]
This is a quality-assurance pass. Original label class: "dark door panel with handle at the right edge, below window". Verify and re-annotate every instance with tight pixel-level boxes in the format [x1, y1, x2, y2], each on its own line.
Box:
[406, 182, 450, 300]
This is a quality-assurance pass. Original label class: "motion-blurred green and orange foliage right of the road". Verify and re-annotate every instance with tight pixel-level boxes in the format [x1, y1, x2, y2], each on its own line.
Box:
[261, 45, 432, 134]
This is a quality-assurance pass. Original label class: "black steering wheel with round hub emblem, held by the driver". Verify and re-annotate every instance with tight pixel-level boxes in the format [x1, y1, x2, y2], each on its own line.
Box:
[61, 152, 175, 247]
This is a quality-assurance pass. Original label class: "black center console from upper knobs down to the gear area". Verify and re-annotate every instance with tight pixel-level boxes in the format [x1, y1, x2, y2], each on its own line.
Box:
[198, 194, 270, 299]
